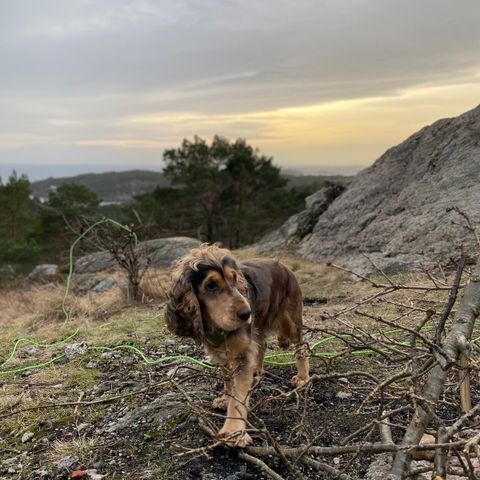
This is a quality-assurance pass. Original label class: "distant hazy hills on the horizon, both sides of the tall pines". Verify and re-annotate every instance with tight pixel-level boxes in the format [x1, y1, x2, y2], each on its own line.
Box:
[31, 170, 352, 203]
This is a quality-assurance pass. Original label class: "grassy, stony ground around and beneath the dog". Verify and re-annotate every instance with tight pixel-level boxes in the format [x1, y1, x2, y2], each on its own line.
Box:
[0, 251, 480, 480]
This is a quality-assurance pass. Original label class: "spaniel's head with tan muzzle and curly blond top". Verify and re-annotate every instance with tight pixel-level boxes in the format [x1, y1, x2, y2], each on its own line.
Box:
[165, 245, 252, 341]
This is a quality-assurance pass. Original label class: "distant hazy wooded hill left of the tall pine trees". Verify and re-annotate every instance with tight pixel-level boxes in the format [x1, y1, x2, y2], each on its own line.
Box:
[31, 170, 168, 202]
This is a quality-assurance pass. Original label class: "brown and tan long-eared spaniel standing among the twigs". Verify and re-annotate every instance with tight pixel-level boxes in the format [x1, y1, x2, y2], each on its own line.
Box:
[165, 245, 309, 447]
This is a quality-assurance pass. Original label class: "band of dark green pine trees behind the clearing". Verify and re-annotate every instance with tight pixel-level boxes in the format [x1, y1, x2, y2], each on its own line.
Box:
[0, 136, 350, 270]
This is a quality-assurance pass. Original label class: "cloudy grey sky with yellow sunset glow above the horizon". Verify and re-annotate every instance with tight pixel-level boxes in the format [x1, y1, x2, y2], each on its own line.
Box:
[0, 0, 480, 179]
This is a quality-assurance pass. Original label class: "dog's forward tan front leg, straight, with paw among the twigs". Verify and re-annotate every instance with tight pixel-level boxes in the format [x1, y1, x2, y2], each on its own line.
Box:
[218, 365, 254, 447]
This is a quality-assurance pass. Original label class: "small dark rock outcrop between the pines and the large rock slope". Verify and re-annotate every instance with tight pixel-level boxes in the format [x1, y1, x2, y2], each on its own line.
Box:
[259, 183, 345, 253]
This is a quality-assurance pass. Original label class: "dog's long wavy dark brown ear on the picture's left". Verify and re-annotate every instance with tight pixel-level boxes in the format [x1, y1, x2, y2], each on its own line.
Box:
[165, 273, 204, 342]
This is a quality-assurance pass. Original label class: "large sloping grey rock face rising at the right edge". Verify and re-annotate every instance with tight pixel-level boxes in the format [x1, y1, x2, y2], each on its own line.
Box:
[299, 106, 480, 273]
